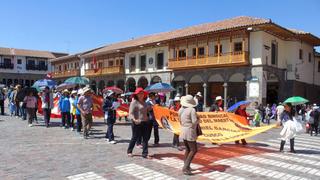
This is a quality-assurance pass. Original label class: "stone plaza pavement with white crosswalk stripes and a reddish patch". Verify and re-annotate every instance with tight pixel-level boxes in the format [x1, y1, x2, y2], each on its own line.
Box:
[0, 112, 320, 180]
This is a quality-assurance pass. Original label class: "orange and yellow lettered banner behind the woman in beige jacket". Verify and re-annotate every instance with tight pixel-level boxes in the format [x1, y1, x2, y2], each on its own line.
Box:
[153, 106, 276, 143]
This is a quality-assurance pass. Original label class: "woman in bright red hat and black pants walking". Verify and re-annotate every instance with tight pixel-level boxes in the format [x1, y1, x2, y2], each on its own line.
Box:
[127, 87, 151, 159]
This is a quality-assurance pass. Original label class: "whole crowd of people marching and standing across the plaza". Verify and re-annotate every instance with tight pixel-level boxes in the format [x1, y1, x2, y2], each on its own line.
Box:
[0, 85, 319, 175]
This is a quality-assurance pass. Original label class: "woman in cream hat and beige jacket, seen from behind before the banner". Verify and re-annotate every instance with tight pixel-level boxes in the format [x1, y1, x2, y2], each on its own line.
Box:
[179, 95, 199, 175]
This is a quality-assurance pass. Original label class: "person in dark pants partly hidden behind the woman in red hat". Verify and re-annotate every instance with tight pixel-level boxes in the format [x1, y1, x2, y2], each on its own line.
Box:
[146, 93, 160, 146]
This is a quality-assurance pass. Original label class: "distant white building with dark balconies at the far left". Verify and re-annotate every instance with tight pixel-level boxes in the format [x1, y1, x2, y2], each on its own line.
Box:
[0, 48, 67, 86]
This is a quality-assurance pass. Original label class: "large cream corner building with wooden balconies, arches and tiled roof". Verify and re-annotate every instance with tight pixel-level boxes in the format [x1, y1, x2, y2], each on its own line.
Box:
[50, 16, 320, 106]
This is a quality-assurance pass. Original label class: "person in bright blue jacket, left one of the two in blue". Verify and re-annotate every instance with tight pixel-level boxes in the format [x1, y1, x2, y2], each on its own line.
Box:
[59, 89, 71, 129]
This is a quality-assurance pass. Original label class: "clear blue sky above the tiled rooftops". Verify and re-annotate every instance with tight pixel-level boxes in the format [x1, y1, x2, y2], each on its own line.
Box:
[0, 0, 320, 53]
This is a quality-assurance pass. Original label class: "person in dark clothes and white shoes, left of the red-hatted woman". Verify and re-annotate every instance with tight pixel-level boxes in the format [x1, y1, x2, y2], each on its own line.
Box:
[102, 91, 116, 144]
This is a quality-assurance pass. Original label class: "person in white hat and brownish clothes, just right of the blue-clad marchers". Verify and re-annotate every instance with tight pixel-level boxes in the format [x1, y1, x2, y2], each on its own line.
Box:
[77, 87, 93, 139]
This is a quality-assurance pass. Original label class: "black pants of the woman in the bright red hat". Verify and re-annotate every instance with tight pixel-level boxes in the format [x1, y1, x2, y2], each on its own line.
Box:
[127, 122, 149, 156]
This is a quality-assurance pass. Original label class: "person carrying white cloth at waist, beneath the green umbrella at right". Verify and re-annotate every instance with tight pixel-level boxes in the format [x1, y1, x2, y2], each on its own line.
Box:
[280, 103, 297, 153]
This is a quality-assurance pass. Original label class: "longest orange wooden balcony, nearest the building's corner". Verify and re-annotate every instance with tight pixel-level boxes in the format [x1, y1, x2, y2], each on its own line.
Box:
[168, 51, 249, 69]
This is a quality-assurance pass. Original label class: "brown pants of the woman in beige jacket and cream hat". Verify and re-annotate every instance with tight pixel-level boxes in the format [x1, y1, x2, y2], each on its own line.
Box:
[182, 140, 198, 171]
